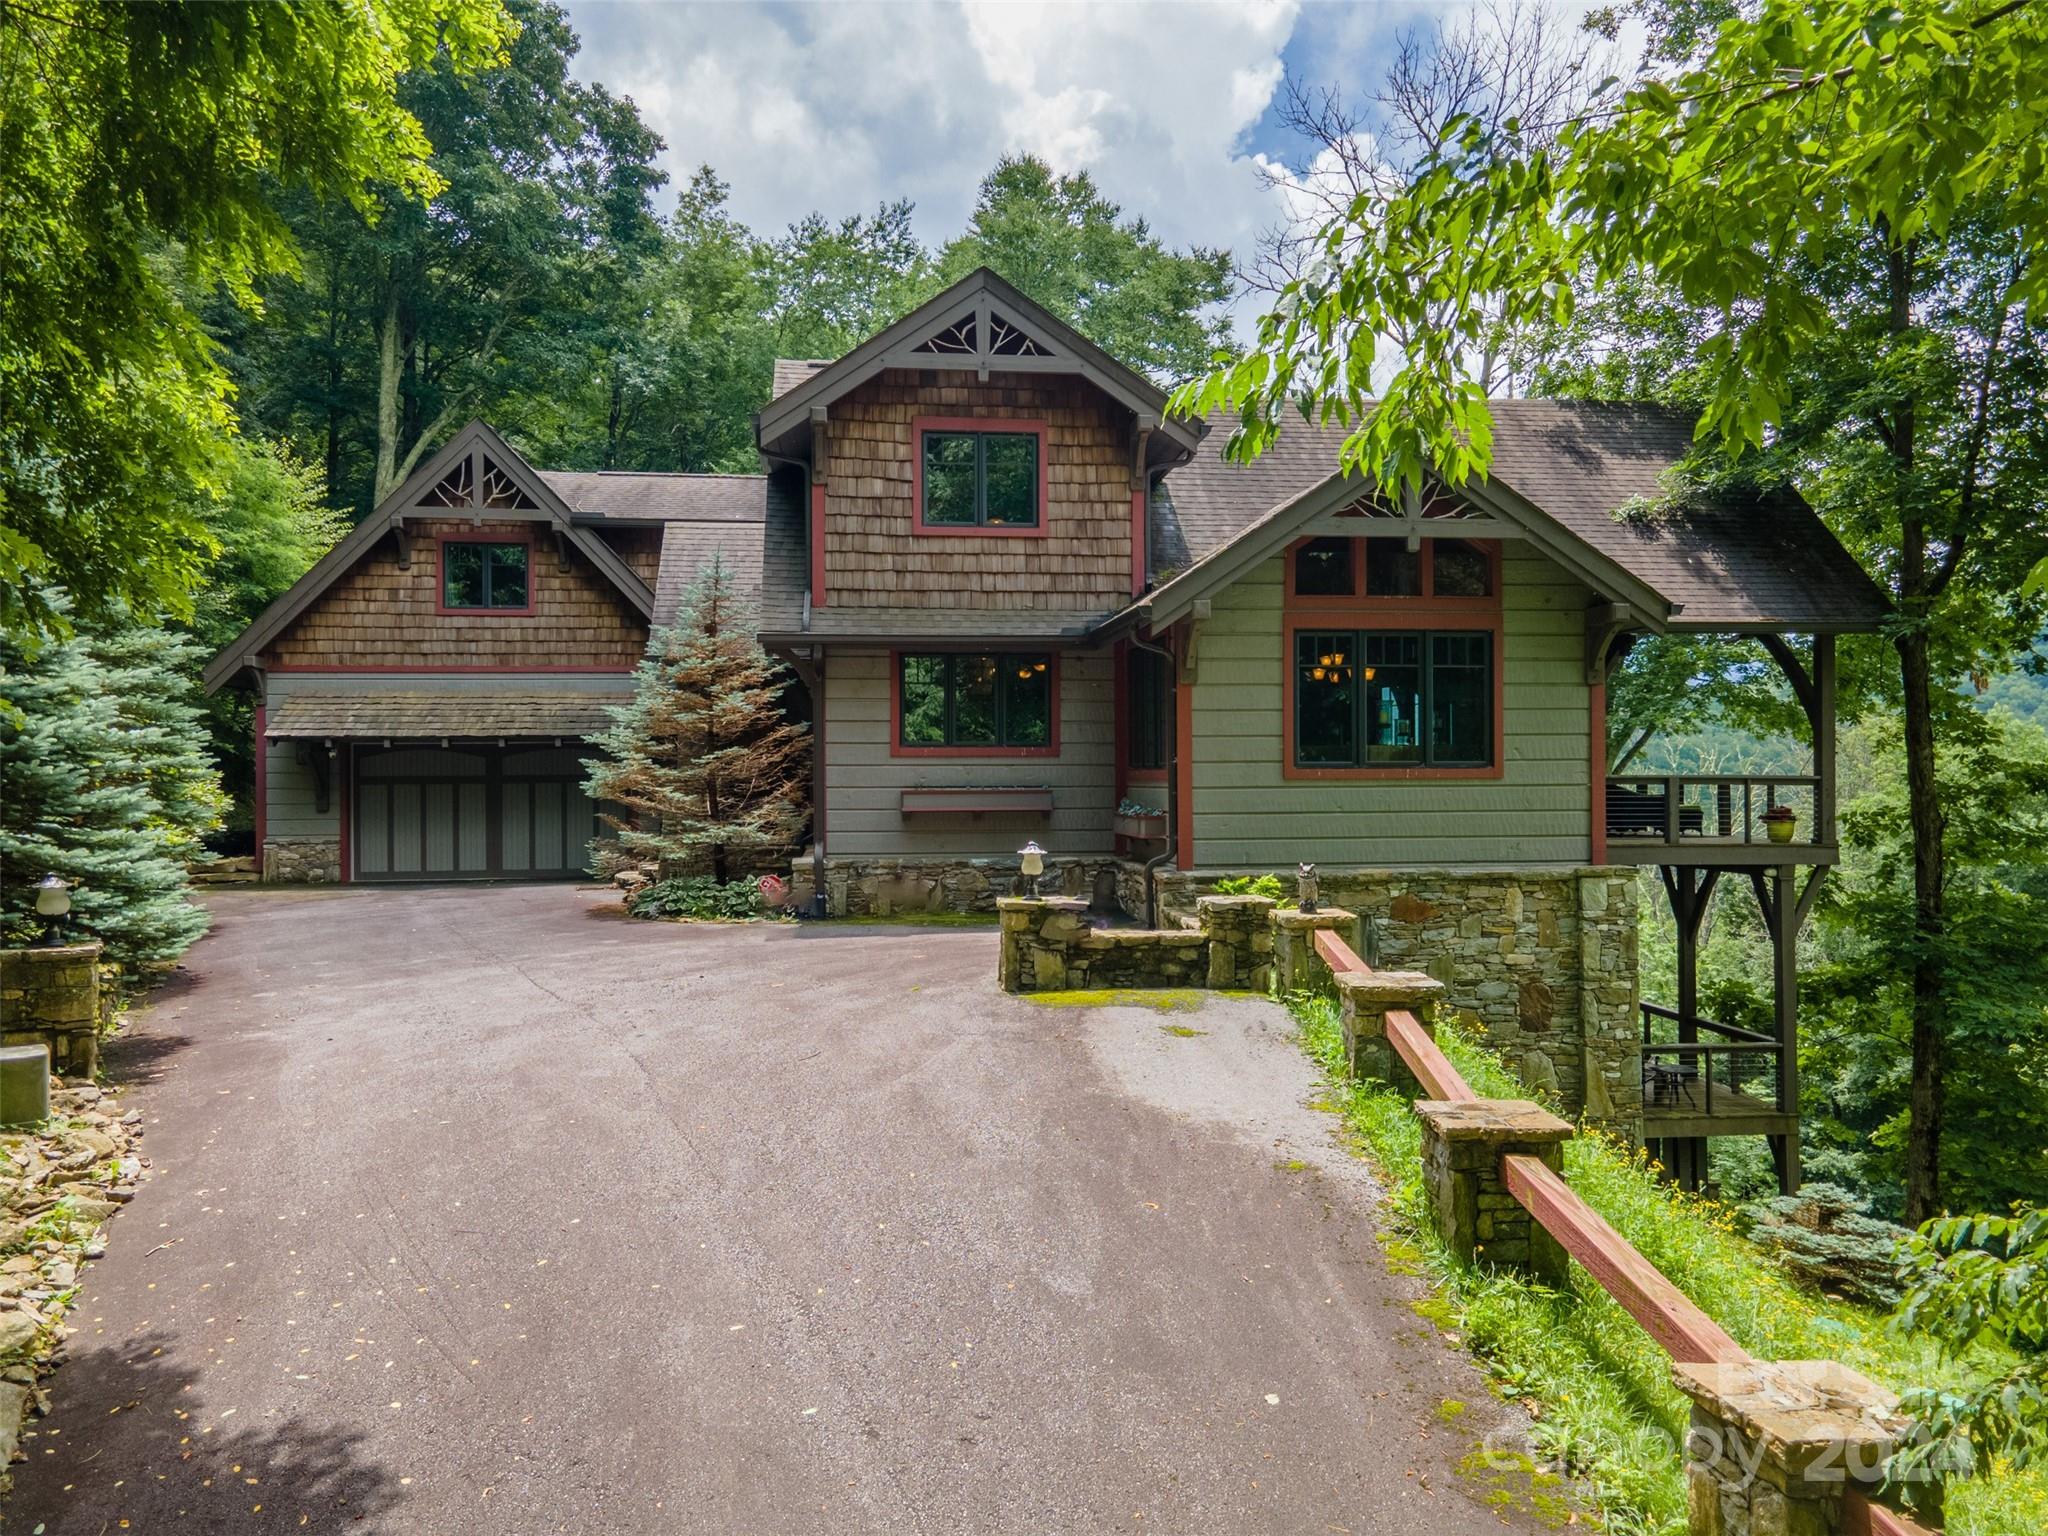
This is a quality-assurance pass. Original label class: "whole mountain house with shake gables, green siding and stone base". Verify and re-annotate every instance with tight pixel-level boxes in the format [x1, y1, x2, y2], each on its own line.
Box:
[207, 270, 1886, 1182]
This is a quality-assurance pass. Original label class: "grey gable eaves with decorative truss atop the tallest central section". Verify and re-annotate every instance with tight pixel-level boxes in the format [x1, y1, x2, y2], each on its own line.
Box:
[754, 266, 1208, 467]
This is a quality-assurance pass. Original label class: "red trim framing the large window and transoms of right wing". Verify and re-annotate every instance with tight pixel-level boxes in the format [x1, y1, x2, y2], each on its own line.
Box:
[1280, 535, 1507, 780]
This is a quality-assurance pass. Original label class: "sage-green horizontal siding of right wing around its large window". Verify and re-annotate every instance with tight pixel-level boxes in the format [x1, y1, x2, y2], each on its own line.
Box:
[1192, 543, 1593, 868]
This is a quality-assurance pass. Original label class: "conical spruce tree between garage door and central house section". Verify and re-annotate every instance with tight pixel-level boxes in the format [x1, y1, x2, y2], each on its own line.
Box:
[584, 557, 811, 883]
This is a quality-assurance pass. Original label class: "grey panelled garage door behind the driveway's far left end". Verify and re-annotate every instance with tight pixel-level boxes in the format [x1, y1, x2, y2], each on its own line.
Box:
[352, 748, 598, 881]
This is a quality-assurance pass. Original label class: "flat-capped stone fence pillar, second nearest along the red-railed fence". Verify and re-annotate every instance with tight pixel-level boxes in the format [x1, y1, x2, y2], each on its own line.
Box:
[1415, 1098, 1571, 1286]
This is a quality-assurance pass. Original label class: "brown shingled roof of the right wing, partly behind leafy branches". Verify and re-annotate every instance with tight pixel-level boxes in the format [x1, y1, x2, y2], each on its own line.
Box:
[1151, 399, 1888, 629]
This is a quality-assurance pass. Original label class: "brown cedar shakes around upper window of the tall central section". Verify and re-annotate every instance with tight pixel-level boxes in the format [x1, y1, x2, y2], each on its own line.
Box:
[825, 369, 1133, 612]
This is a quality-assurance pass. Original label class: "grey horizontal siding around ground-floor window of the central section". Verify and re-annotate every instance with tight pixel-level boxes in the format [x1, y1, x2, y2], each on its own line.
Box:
[825, 647, 1116, 858]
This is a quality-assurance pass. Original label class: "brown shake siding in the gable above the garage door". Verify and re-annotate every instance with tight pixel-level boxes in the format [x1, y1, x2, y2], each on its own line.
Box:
[262, 518, 659, 672]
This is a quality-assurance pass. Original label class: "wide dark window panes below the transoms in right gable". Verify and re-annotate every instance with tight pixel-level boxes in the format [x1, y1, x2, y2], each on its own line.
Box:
[1294, 629, 1493, 768]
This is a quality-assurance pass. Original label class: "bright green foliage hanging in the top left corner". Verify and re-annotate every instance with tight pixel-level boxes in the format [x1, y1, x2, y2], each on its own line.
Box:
[0, 0, 508, 633]
